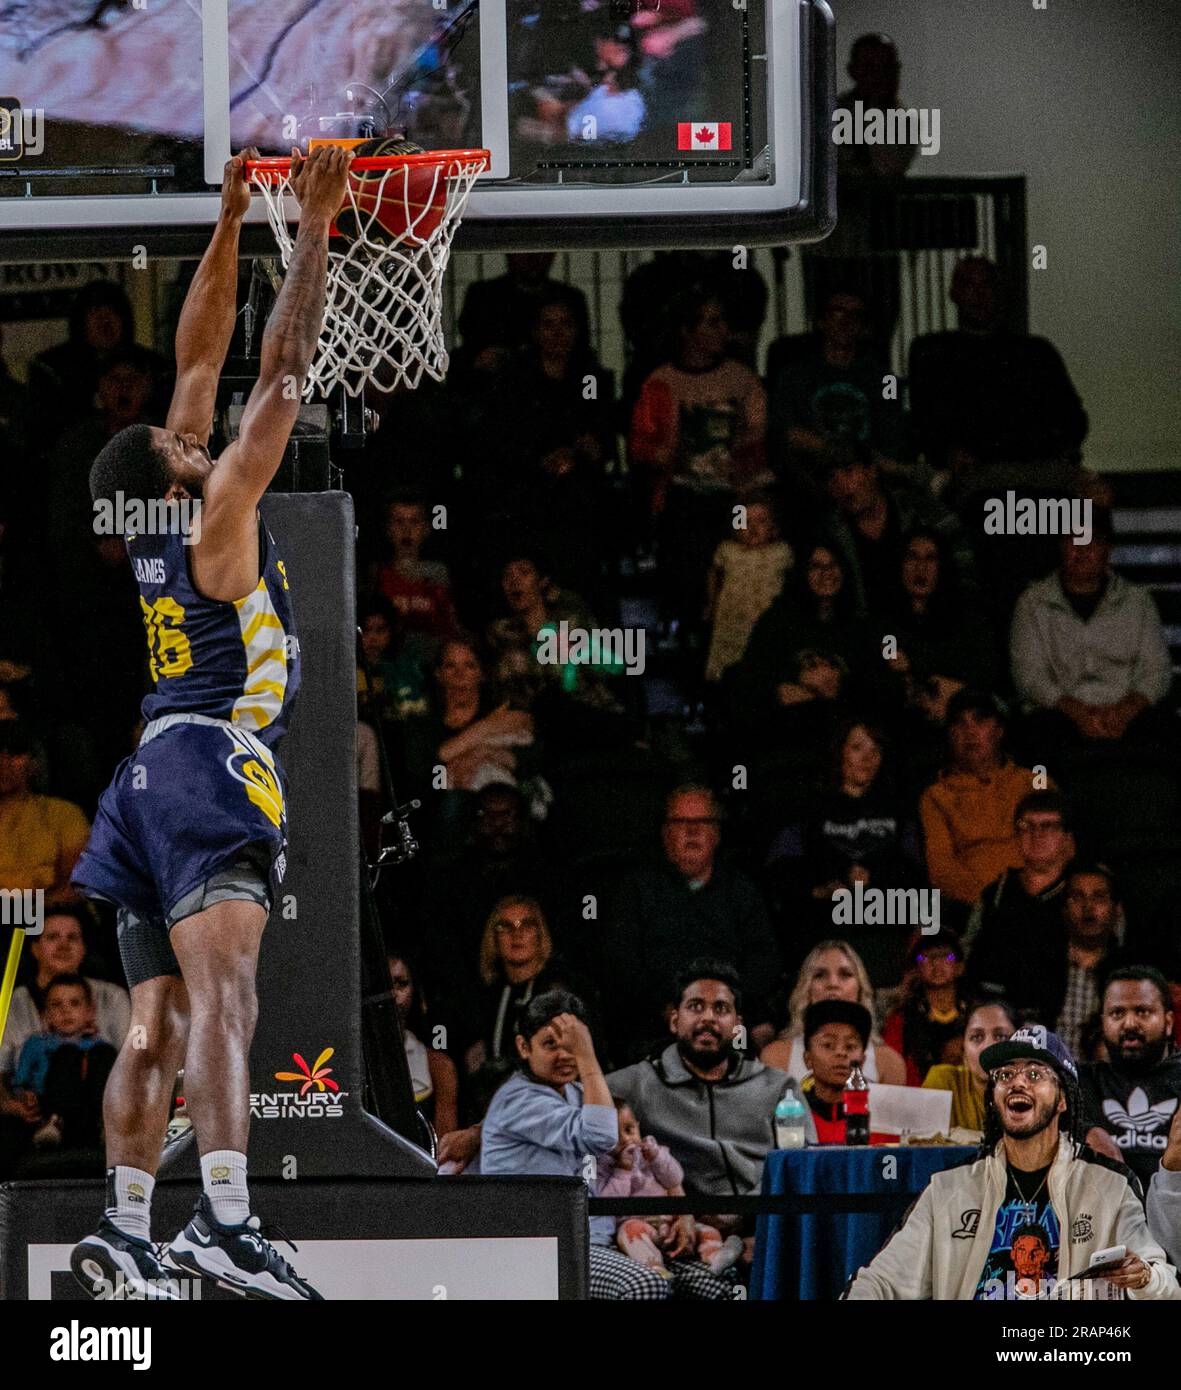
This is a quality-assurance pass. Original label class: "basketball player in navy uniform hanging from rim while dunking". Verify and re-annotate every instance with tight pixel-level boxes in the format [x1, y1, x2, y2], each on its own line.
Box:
[71, 146, 352, 1300]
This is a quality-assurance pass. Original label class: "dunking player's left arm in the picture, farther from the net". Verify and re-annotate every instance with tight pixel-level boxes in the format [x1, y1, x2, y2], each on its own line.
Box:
[165, 149, 258, 443]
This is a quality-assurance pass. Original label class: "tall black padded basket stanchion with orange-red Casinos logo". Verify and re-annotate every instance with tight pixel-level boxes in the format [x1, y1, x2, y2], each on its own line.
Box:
[161, 492, 435, 1180]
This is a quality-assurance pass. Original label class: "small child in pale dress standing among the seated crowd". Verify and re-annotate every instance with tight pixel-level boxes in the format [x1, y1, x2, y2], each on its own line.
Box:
[706, 492, 793, 681]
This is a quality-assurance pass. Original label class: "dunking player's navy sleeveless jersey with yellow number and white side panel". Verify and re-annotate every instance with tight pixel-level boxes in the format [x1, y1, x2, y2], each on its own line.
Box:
[126, 517, 299, 748]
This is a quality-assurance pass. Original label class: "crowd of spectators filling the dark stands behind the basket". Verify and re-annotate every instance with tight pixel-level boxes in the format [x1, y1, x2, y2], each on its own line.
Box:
[0, 35, 1181, 1297]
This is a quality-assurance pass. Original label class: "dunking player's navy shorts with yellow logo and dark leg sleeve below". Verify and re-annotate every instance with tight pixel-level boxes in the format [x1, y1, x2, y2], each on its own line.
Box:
[71, 714, 286, 984]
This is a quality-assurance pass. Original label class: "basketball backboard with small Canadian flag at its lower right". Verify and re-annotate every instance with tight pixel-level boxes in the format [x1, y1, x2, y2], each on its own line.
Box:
[0, 0, 832, 259]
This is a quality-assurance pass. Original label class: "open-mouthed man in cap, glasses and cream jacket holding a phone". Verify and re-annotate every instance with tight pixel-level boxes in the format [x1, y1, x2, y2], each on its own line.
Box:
[845, 1023, 1181, 1301]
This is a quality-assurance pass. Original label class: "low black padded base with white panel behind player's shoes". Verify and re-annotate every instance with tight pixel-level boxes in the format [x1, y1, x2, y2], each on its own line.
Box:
[0, 1176, 588, 1301]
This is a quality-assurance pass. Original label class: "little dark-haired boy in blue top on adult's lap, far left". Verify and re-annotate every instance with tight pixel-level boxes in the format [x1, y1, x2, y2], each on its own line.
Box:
[10, 974, 117, 1148]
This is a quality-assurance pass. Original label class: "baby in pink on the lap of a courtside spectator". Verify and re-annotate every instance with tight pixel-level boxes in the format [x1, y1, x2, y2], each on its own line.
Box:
[595, 1101, 743, 1275]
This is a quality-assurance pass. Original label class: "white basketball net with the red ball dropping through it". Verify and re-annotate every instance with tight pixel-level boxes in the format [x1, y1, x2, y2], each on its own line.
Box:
[253, 152, 485, 396]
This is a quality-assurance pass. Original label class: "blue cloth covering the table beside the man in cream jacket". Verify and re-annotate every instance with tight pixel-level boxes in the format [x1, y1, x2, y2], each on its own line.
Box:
[750, 1145, 977, 1300]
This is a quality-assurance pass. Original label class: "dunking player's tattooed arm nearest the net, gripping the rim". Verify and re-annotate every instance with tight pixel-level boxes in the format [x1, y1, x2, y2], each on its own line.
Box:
[206, 145, 353, 525]
